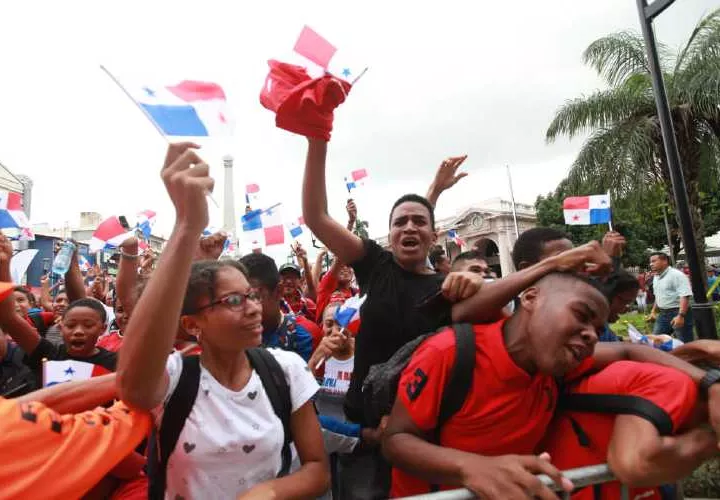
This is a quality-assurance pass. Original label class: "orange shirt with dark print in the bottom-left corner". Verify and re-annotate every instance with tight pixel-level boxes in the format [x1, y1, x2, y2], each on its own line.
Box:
[0, 398, 150, 499]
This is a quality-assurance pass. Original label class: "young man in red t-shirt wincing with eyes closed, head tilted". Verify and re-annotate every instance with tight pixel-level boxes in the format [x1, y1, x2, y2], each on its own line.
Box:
[383, 273, 608, 499]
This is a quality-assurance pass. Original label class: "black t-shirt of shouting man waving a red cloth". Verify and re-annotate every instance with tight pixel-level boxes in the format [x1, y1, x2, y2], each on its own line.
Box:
[345, 240, 452, 423]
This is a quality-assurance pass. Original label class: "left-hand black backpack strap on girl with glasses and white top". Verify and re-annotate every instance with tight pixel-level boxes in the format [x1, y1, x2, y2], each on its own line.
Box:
[147, 356, 200, 500]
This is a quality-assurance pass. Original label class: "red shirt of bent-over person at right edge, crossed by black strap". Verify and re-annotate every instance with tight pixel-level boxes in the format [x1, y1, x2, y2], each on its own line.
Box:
[542, 361, 697, 500]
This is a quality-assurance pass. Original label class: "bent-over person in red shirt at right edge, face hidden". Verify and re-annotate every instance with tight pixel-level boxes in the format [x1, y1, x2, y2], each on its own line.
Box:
[541, 361, 717, 500]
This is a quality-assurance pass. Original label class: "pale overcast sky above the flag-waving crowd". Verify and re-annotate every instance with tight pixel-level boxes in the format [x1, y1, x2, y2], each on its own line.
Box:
[0, 0, 720, 262]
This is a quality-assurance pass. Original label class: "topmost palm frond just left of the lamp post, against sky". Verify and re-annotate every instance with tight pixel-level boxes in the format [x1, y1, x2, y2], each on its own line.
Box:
[583, 31, 667, 86]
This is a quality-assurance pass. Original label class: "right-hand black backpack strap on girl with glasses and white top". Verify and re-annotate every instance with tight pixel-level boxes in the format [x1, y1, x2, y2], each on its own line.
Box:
[246, 347, 292, 477]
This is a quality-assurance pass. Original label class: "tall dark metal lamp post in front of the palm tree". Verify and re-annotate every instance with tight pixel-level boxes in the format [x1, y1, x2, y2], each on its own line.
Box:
[637, 0, 717, 339]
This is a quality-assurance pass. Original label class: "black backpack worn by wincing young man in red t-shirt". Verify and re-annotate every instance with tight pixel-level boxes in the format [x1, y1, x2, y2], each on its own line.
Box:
[362, 323, 475, 438]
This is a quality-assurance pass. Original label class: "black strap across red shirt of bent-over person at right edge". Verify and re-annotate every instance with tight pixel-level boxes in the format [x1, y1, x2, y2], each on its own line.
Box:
[560, 394, 673, 436]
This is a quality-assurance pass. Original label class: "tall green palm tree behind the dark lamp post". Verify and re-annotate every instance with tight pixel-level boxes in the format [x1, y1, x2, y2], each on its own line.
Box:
[546, 9, 720, 264]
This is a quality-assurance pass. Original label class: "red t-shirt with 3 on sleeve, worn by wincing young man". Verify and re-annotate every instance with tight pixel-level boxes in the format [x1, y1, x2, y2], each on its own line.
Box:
[391, 320, 593, 497]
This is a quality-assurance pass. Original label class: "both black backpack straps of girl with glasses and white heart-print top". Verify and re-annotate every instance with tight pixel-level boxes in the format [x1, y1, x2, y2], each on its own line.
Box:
[147, 347, 292, 500]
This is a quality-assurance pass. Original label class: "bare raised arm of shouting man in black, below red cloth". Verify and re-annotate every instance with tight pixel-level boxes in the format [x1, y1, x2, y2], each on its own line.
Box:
[302, 138, 365, 262]
